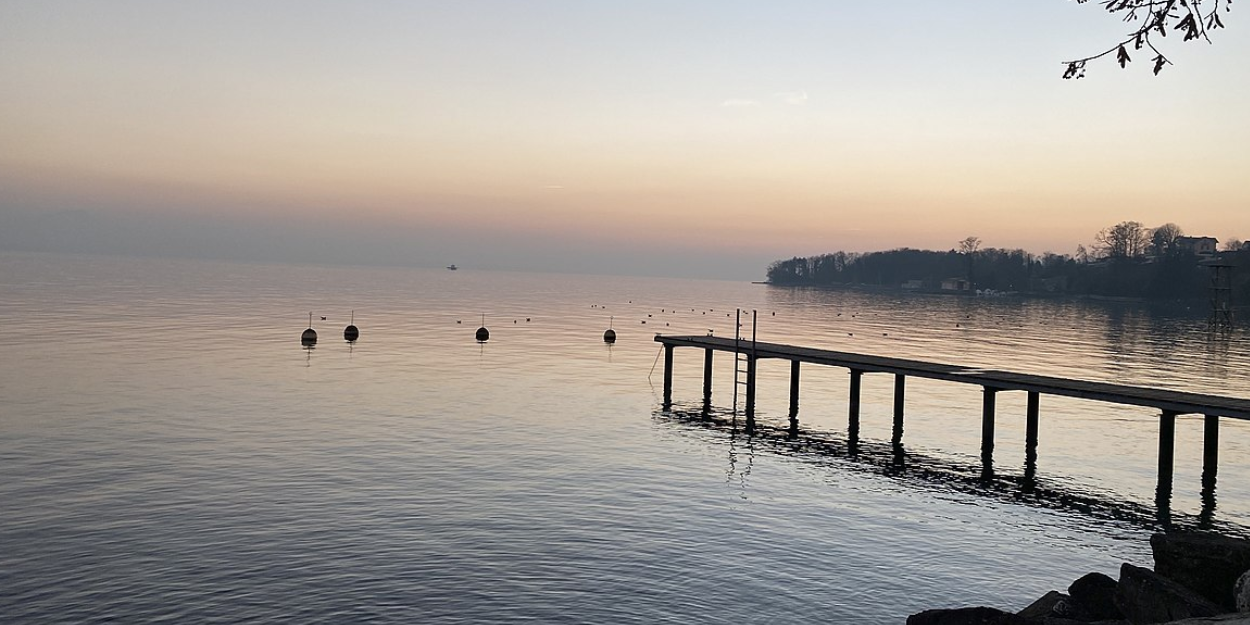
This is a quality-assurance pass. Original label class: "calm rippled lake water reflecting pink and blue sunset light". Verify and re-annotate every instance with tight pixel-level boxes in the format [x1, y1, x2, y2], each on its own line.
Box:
[0, 254, 1250, 624]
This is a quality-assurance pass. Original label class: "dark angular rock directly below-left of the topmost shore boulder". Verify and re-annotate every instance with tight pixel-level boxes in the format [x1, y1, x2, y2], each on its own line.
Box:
[1115, 564, 1223, 625]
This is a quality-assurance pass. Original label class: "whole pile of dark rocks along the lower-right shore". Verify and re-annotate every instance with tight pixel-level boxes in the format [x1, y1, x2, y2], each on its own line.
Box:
[908, 533, 1250, 625]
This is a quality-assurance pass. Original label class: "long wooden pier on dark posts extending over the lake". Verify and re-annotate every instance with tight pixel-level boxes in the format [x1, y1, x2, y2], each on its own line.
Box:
[655, 335, 1250, 510]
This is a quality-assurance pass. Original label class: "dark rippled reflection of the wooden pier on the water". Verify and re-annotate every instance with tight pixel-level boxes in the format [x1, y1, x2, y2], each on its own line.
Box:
[653, 403, 1235, 538]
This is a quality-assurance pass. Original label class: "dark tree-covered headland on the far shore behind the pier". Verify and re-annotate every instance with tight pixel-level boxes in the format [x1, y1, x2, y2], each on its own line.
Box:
[768, 221, 1250, 305]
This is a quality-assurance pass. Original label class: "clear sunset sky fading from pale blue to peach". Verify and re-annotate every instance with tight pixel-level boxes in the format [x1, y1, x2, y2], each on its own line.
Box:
[0, 0, 1250, 280]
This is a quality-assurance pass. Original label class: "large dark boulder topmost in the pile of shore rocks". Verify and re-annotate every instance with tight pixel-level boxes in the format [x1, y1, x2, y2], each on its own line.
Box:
[1150, 531, 1250, 611]
